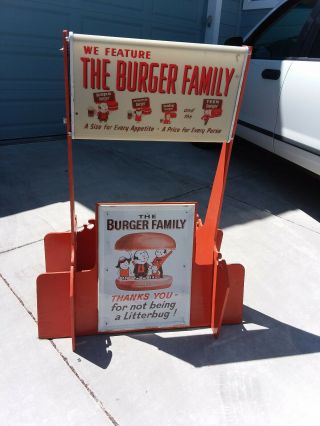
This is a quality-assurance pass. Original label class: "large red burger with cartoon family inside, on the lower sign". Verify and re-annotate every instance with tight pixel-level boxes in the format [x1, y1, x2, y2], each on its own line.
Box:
[114, 232, 176, 291]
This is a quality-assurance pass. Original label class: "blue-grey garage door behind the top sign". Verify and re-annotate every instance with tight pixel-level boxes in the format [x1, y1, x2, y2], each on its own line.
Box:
[0, 0, 207, 140]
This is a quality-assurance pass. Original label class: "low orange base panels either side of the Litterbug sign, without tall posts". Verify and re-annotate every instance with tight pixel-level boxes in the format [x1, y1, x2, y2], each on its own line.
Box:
[37, 220, 244, 338]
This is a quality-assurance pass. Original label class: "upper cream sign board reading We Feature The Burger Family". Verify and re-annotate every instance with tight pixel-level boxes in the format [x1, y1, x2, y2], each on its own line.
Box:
[70, 33, 249, 142]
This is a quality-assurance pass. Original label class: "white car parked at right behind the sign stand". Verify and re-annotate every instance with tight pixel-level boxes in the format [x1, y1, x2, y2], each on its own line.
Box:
[230, 0, 320, 175]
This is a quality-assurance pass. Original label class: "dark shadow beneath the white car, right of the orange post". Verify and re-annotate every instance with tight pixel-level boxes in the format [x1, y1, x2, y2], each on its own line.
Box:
[226, 138, 320, 226]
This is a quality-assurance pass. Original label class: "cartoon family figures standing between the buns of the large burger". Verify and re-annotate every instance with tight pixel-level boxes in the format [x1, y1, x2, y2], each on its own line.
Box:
[116, 249, 172, 280]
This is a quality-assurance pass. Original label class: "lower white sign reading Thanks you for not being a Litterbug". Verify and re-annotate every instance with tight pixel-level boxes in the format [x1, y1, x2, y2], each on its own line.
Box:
[98, 203, 195, 332]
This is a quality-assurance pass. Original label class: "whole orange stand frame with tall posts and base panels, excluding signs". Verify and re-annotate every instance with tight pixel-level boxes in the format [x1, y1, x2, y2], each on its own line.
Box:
[37, 31, 251, 350]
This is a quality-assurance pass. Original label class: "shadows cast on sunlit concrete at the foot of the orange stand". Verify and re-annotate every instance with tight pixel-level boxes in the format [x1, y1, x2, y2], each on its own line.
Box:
[76, 306, 320, 369]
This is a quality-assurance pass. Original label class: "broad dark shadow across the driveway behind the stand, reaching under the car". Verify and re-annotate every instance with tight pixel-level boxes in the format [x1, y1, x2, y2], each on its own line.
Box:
[0, 140, 320, 227]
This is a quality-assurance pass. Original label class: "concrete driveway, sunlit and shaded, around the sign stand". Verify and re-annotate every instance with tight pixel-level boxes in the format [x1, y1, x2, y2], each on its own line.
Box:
[0, 140, 320, 426]
